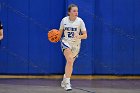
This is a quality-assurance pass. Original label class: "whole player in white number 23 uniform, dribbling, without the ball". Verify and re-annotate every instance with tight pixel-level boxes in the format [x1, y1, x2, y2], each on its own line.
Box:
[59, 4, 87, 91]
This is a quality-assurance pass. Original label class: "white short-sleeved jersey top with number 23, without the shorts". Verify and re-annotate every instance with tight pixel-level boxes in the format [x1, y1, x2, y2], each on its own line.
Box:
[60, 16, 86, 41]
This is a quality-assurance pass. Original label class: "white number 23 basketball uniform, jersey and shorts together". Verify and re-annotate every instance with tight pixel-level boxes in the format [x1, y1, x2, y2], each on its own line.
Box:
[60, 16, 86, 58]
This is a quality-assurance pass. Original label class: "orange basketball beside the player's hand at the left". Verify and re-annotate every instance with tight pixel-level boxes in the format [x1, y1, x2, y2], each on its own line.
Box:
[48, 29, 60, 43]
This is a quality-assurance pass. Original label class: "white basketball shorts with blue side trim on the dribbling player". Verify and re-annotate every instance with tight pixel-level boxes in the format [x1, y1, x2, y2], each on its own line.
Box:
[61, 39, 81, 58]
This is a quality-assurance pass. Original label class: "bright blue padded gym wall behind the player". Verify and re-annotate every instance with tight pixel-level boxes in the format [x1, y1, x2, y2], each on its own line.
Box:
[0, 0, 140, 75]
